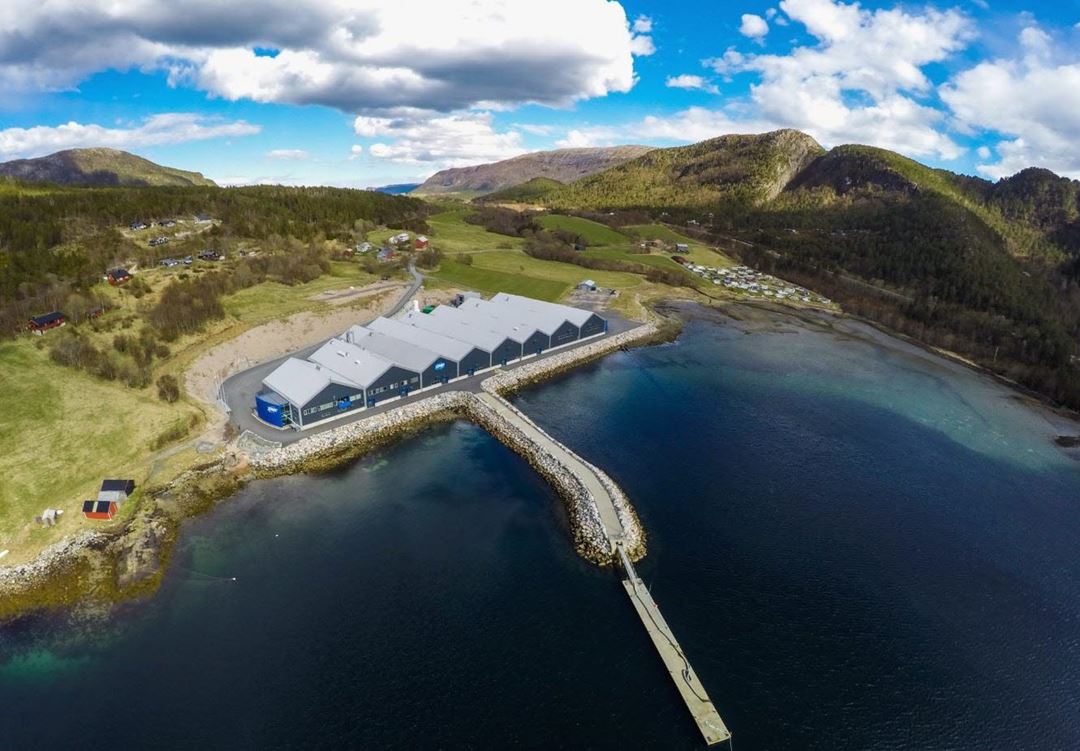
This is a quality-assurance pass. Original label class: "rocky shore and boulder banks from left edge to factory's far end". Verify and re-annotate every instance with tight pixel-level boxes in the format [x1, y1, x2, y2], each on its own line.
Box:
[0, 318, 681, 622]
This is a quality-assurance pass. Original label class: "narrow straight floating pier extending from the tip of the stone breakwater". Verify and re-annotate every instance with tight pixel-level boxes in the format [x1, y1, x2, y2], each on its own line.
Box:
[618, 545, 731, 746]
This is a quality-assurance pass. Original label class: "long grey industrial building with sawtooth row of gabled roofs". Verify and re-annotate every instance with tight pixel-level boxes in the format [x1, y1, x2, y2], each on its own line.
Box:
[255, 293, 607, 430]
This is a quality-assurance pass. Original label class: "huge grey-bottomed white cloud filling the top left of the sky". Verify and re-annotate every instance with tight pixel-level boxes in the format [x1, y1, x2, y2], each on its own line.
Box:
[0, 0, 639, 112]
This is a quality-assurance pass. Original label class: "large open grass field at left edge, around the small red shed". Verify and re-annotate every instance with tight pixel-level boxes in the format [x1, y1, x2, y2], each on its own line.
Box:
[0, 334, 198, 564]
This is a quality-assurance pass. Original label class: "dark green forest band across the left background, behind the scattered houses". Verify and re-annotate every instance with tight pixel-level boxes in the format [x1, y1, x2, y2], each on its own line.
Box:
[0, 183, 429, 335]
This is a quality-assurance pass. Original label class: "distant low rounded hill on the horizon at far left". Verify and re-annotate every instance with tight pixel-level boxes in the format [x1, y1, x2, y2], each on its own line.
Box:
[0, 148, 214, 187]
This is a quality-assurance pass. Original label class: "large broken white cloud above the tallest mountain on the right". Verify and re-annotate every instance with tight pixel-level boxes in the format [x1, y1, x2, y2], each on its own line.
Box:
[705, 0, 971, 159]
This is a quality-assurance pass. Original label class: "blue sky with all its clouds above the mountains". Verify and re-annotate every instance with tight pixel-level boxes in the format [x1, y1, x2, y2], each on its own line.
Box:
[0, 0, 1080, 187]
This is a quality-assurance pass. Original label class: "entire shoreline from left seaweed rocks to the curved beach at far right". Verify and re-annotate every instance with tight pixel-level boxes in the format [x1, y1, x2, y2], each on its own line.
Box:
[6, 297, 1080, 622]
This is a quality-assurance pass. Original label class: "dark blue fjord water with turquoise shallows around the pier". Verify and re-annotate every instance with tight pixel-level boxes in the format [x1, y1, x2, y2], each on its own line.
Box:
[0, 304, 1080, 751]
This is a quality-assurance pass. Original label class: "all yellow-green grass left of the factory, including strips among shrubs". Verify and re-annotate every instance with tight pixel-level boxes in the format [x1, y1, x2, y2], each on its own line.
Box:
[0, 261, 395, 563]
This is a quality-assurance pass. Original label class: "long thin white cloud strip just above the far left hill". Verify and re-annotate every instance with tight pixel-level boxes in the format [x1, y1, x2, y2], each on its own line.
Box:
[0, 112, 259, 158]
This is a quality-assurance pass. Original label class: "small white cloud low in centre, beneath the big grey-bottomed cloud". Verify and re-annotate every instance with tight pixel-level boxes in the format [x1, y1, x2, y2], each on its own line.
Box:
[354, 112, 525, 169]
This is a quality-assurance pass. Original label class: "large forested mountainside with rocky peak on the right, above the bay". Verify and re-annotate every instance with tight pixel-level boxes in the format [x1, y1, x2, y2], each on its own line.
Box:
[536, 131, 1080, 407]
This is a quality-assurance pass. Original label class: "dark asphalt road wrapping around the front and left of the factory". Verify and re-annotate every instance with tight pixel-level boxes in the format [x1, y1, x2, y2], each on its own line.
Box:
[221, 311, 639, 444]
